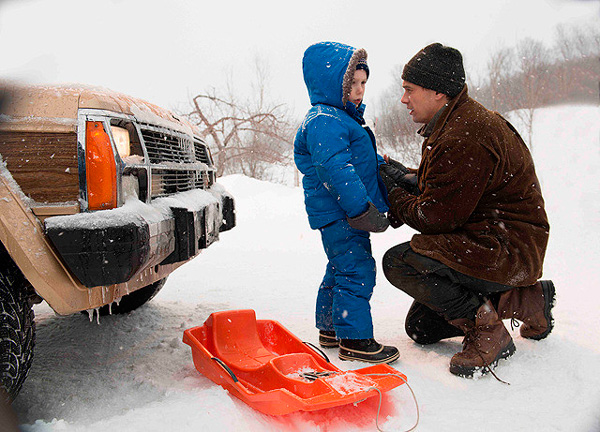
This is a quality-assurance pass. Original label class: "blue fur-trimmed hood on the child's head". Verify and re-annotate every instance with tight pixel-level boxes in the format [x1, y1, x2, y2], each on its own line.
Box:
[302, 42, 367, 109]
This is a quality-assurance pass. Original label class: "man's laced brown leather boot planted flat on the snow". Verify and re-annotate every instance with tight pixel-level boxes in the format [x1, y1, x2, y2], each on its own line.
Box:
[450, 300, 516, 378]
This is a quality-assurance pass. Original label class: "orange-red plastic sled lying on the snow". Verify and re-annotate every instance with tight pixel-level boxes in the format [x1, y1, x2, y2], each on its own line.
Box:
[183, 309, 406, 415]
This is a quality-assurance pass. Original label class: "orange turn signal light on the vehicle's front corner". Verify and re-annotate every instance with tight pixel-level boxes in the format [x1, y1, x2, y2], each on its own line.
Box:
[85, 121, 117, 210]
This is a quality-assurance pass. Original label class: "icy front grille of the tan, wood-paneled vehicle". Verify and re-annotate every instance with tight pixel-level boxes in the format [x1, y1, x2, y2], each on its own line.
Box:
[140, 124, 215, 199]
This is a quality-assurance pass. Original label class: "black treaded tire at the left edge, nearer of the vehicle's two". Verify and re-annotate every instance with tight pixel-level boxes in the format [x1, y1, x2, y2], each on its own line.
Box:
[0, 244, 35, 401]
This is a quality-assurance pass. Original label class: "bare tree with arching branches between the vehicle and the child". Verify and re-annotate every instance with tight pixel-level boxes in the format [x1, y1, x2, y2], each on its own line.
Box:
[187, 60, 293, 180]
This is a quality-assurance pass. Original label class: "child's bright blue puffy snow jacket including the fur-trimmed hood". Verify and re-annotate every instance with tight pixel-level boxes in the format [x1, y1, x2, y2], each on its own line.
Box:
[294, 42, 388, 229]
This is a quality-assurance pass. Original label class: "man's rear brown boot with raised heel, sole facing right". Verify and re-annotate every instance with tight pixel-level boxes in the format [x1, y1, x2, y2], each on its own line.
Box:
[498, 280, 556, 340]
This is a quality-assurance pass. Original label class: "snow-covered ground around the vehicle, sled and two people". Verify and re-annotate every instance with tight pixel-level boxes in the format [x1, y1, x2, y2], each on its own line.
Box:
[13, 106, 600, 432]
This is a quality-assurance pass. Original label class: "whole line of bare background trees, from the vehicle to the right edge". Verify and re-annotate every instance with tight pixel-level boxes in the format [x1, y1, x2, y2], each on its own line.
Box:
[184, 26, 600, 183]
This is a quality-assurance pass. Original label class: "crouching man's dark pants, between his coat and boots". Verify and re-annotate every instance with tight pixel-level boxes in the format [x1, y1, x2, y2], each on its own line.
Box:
[383, 242, 514, 344]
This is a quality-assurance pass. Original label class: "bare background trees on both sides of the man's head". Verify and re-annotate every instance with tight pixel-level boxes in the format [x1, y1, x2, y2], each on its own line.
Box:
[376, 22, 600, 160]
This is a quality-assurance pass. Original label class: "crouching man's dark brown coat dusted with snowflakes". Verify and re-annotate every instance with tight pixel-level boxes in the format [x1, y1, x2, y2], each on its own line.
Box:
[389, 86, 549, 287]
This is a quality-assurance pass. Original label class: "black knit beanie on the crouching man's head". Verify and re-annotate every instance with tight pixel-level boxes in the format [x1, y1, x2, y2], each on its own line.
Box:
[402, 43, 465, 98]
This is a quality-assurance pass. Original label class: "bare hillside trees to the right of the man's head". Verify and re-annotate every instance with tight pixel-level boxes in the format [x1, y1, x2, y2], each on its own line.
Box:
[474, 26, 600, 145]
